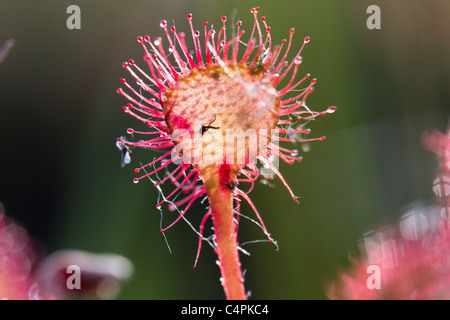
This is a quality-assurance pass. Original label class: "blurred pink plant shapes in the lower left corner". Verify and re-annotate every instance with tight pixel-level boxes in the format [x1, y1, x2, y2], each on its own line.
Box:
[0, 203, 133, 300]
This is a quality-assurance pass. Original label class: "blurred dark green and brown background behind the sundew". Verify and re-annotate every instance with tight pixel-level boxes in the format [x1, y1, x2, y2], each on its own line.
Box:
[0, 0, 450, 299]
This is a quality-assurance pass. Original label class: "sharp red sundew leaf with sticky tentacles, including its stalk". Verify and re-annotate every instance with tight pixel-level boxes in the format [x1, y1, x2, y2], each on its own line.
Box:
[116, 8, 336, 299]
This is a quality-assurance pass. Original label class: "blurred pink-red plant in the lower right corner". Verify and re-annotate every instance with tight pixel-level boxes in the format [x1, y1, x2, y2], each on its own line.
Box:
[327, 122, 450, 300]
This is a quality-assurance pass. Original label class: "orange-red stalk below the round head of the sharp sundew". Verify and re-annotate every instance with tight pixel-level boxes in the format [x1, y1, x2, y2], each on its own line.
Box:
[205, 165, 246, 300]
